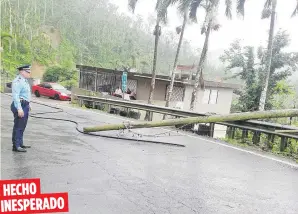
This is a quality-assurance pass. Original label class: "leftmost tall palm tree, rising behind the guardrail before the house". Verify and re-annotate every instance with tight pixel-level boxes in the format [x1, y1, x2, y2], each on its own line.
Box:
[128, 0, 176, 120]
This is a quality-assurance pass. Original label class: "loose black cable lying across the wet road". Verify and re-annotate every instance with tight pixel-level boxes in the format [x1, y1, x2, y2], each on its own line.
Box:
[1, 92, 185, 147]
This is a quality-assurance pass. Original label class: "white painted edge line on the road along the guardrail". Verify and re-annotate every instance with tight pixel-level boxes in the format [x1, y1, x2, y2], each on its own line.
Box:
[32, 98, 298, 168]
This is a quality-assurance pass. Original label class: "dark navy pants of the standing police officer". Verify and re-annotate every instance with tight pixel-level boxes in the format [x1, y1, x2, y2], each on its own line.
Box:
[10, 101, 29, 148]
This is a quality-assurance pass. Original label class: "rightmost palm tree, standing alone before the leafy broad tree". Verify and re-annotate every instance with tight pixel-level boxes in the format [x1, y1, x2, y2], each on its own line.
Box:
[237, 0, 298, 111]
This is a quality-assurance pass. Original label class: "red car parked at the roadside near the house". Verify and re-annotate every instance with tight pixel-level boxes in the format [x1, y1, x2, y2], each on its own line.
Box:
[32, 82, 71, 100]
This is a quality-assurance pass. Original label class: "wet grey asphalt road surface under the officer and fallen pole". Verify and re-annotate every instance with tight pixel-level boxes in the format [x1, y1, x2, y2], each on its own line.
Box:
[1, 94, 298, 214]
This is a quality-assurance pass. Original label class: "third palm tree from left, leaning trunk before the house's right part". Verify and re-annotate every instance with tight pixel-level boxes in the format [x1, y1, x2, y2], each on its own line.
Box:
[189, 0, 232, 111]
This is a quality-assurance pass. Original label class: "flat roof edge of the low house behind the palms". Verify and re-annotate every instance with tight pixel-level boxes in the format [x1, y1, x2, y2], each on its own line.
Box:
[76, 65, 241, 89]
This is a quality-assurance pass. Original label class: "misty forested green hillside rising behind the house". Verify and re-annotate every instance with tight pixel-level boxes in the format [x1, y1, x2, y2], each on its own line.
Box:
[1, 0, 198, 79]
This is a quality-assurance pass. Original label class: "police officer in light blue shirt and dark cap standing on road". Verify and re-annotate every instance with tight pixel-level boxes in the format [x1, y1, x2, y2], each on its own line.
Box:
[11, 65, 31, 152]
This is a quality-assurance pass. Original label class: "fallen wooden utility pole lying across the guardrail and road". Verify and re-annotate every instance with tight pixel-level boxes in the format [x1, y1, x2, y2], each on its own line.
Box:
[83, 109, 298, 132]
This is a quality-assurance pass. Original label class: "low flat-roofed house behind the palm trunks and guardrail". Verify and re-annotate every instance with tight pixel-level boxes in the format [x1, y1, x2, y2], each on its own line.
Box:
[77, 65, 240, 137]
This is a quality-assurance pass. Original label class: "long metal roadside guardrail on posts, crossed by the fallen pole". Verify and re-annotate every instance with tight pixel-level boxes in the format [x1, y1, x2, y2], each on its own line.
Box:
[75, 95, 298, 151]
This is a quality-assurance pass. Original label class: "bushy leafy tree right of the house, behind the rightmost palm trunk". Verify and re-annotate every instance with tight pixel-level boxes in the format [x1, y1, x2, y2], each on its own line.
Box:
[220, 31, 298, 112]
